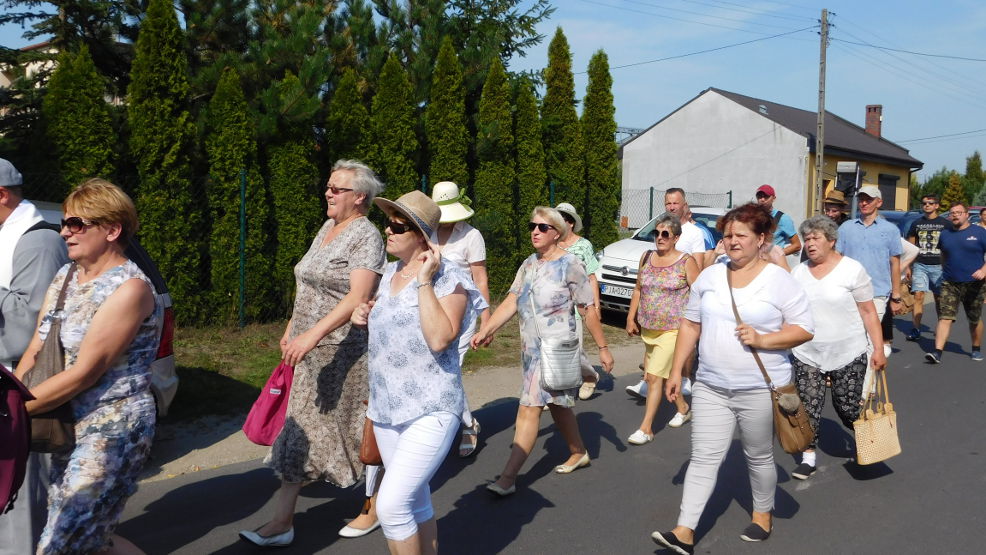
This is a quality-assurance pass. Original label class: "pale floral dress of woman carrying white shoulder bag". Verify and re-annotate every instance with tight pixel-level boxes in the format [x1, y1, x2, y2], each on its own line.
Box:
[510, 253, 593, 407]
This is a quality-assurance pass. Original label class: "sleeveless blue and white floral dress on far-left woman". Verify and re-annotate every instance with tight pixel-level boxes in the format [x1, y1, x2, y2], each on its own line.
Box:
[38, 260, 163, 554]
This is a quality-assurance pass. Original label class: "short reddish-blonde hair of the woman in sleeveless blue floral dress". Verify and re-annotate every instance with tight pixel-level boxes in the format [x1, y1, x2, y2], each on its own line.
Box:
[62, 177, 140, 242]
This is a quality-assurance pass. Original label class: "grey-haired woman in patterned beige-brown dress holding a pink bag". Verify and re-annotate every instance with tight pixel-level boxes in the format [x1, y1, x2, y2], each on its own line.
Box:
[240, 160, 386, 546]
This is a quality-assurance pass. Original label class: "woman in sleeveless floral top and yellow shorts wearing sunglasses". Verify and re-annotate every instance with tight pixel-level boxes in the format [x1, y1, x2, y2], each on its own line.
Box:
[626, 213, 699, 445]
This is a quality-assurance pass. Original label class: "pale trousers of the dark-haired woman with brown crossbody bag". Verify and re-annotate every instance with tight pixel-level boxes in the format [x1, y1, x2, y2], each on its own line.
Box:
[678, 381, 777, 530]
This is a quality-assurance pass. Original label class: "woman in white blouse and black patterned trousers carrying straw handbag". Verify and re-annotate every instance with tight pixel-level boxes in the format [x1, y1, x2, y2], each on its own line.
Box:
[791, 216, 887, 480]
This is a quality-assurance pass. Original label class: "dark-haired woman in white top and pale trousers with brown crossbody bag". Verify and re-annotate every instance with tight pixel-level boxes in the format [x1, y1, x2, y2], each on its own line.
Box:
[651, 204, 814, 554]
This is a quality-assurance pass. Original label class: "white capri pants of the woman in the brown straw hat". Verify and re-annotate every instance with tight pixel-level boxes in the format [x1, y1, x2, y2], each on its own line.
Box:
[373, 412, 460, 541]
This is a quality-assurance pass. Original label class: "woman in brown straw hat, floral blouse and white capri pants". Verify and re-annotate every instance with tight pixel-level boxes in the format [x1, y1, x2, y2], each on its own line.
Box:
[352, 191, 487, 553]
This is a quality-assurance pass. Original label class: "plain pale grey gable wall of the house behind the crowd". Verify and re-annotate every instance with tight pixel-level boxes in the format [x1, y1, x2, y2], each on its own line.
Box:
[620, 91, 813, 227]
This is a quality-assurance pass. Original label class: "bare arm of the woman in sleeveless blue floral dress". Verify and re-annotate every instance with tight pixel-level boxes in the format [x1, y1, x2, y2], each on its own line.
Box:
[18, 279, 154, 414]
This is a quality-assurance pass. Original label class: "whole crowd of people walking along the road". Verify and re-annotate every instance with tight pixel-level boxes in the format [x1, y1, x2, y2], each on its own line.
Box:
[0, 152, 986, 554]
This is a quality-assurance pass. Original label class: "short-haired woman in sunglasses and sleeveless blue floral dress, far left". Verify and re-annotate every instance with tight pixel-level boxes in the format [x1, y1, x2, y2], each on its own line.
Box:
[17, 179, 163, 553]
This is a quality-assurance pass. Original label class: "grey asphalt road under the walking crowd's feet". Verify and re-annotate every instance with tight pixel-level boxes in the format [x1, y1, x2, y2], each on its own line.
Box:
[118, 319, 986, 555]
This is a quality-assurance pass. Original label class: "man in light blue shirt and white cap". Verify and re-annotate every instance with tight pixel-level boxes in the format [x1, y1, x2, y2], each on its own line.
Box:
[835, 185, 904, 395]
